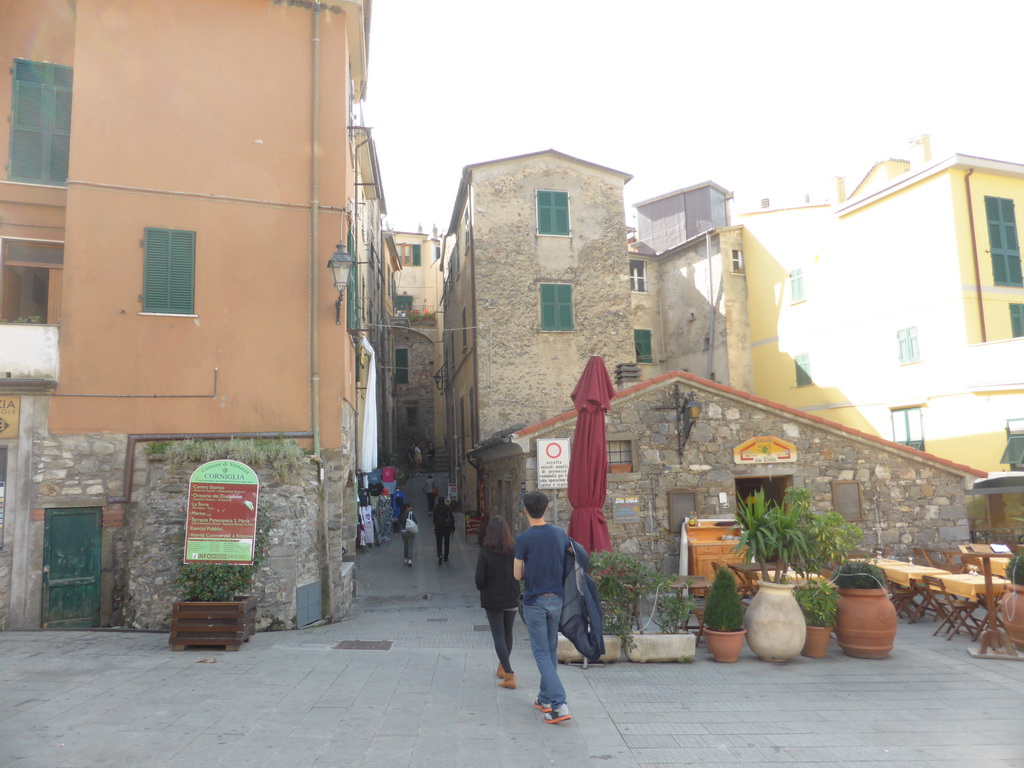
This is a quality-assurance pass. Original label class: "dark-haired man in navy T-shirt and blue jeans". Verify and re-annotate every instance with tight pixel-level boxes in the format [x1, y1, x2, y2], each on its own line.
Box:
[513, 490, 572, 723]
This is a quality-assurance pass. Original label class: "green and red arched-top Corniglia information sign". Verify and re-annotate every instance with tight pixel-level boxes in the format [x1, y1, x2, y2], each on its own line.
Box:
[184, 459, 259, 565]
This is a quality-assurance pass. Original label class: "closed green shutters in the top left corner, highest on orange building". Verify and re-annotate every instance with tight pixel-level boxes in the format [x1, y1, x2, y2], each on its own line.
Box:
[7, 58, 73, 184]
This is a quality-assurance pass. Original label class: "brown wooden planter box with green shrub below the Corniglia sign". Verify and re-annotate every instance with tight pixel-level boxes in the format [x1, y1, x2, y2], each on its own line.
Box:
[169, 509, 271, 650]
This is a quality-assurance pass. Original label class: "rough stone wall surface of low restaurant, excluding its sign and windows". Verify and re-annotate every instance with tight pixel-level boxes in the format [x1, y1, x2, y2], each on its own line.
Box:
[484, 378, 970, 572]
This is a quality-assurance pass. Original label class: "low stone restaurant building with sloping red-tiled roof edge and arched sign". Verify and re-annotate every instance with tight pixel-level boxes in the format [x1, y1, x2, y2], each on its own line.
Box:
[471, 371, 986, 572]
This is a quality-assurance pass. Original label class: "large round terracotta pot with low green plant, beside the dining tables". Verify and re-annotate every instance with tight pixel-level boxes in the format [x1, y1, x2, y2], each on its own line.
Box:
[833, 560, 896, 658]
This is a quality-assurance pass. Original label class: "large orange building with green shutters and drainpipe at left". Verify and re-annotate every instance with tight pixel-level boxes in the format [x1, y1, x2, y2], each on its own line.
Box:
[0, 0, 378, 629]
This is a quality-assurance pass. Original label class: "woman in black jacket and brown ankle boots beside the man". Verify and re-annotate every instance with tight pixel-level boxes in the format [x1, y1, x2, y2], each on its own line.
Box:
[476, 515, 519, 688]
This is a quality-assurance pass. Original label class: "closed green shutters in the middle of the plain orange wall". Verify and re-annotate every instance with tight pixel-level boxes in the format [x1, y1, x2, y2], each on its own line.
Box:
[142, 226, 196, 314]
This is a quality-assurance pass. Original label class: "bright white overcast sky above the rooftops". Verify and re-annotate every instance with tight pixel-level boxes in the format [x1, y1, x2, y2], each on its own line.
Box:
[365, 0, 1024, 232]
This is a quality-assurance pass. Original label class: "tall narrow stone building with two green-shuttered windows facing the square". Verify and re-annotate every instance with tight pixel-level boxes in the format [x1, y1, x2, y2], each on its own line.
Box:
[442, 150, 635, 509]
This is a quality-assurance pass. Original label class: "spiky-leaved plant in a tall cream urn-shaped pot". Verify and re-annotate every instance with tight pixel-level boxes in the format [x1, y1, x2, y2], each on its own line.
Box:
[735, 486, 811, 662]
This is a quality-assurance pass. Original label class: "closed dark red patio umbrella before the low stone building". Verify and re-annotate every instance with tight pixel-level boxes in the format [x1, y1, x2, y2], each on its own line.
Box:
[568, 356, 615, 552]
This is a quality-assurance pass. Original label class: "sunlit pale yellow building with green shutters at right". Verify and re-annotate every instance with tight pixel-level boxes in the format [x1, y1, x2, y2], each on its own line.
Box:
[738, 137, 1024, 487]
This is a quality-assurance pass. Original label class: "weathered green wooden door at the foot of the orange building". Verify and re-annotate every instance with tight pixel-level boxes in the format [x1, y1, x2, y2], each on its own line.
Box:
[42, 507, 101, 629]
